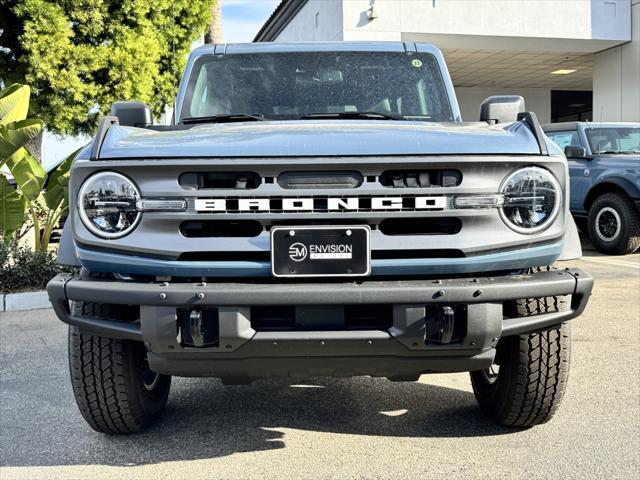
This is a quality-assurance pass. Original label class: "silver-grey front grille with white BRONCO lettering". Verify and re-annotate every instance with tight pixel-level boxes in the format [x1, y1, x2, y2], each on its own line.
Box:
[72, 155, 566, 274]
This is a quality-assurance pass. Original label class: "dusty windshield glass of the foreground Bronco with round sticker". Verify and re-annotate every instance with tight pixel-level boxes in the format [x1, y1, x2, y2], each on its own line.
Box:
[180, 52, 453, 122]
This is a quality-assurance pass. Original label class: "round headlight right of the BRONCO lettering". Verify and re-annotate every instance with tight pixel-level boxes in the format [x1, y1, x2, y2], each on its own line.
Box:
[500, 167, 562, 233]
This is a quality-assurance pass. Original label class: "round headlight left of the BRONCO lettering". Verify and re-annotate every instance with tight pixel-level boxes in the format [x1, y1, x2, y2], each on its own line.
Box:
[78, 172, 141, 238]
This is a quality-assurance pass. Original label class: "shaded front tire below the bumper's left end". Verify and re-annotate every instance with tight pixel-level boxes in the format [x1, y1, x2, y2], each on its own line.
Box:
[69, 302, 171, 433]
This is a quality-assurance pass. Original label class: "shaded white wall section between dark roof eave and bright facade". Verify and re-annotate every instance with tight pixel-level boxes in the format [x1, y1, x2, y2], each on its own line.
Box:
[275, 0, 343, 42]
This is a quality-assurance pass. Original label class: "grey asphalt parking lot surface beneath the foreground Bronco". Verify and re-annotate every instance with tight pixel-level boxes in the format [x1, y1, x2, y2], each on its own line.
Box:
[0, 242, 640, 480]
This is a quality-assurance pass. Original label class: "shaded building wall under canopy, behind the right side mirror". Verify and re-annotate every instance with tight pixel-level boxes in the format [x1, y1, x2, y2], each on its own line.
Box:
[456, 87, 551, 123]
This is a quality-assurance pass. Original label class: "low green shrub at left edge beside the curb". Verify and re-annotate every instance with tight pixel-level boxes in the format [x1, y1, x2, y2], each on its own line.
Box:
[0, 242, 63, 293]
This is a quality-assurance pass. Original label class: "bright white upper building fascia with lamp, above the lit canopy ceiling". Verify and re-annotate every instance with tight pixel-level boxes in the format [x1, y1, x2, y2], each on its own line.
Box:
[342, 0, 631, 41]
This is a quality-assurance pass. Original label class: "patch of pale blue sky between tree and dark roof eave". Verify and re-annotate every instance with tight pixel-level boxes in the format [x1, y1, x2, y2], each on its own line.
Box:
[220, 0, 280, 43]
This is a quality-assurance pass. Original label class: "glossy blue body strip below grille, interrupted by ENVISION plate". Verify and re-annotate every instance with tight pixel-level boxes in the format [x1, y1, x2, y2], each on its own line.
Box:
[76, 241, 564, 277]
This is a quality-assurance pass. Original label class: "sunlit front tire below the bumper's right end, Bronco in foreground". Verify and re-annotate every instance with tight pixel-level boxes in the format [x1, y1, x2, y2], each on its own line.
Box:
[471, 276, 571, 427]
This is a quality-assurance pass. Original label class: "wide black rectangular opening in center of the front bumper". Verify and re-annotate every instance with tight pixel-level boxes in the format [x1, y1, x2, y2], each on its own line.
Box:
[251, 305, 393, 332]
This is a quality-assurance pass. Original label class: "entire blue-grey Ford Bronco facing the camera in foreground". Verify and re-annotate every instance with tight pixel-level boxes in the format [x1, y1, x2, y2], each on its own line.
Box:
[48, 43, 593, 433]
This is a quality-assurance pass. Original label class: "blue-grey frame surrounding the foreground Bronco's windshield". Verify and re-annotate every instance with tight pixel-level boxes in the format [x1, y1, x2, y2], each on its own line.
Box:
[173, 48, 462, 124]
